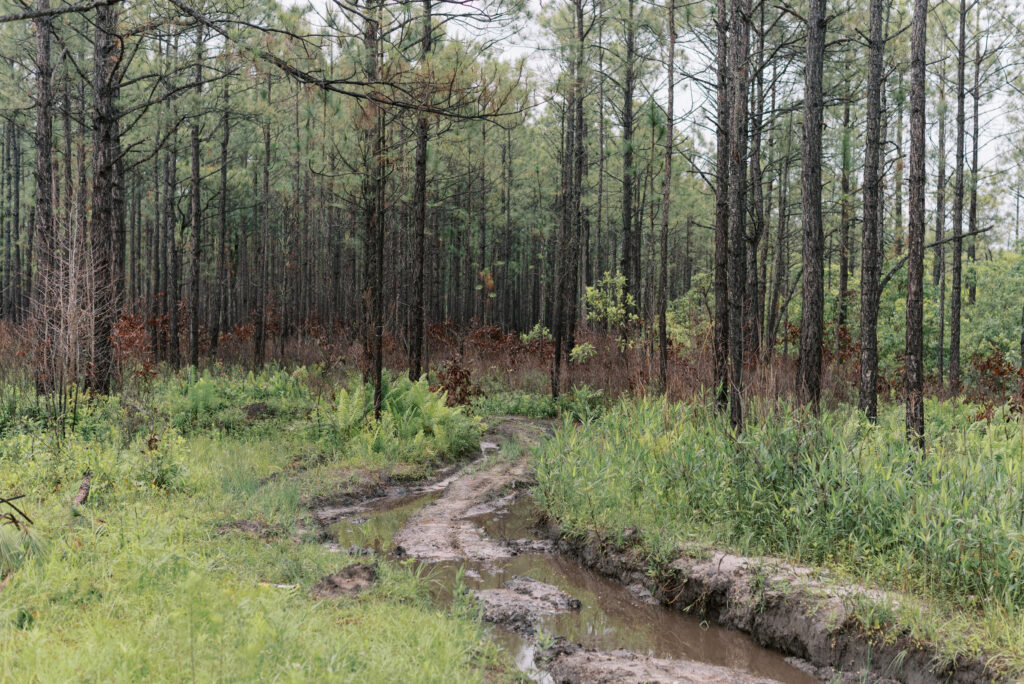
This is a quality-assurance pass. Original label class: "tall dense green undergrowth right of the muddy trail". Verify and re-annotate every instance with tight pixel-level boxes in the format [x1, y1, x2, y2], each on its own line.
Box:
[535, 399, 1024, 672]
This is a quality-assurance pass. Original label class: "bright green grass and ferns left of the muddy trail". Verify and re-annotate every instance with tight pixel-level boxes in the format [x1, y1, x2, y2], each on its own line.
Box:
[0, 372, 512, 682]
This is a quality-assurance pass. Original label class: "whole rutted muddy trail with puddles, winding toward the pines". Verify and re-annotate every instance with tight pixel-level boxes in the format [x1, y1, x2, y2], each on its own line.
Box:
[315, 418, 819, 684]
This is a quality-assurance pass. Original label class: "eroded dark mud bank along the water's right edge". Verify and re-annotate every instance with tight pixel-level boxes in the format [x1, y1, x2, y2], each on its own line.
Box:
[544, 521, 1009, 684]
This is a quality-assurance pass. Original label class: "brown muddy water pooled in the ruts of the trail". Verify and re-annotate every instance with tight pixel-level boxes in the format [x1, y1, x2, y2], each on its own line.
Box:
[331, 464, 818, 684]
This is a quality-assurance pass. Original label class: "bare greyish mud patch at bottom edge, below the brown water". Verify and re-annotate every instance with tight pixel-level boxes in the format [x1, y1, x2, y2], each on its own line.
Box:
[538, 640, 775, 684]
